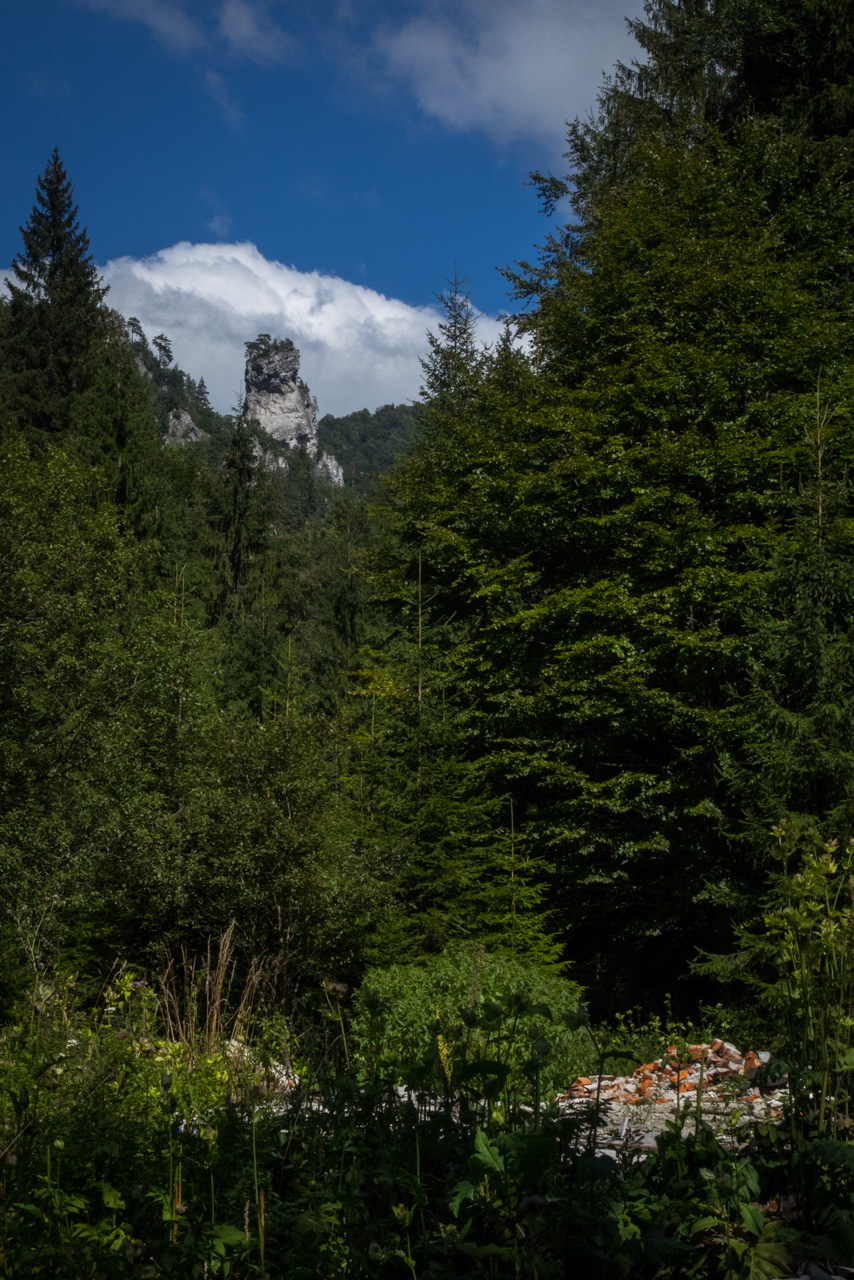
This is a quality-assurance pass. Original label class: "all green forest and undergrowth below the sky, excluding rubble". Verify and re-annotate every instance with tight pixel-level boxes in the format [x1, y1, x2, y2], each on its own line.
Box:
[0, 0, 854, 1280]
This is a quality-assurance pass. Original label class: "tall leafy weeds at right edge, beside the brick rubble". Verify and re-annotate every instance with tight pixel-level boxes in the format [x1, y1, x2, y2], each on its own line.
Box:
[698, 823, 854, 1256]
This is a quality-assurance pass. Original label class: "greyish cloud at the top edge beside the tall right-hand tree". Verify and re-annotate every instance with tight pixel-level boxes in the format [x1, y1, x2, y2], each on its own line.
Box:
[374, 0, 641, 143]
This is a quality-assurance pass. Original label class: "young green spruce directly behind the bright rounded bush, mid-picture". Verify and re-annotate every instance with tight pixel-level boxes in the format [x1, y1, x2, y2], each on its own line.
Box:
[342, 561, 558, 965]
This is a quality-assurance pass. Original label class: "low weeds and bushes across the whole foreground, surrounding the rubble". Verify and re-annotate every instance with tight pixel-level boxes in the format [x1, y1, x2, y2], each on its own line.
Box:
[0, 824, 854, 1280]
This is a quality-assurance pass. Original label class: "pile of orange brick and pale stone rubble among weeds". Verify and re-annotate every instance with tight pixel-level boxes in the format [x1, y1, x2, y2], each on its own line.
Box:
[558, 1039, 787, 1153]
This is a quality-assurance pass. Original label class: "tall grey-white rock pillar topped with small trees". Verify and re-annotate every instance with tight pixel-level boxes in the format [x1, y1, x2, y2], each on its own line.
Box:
[243, 343, 318, 458]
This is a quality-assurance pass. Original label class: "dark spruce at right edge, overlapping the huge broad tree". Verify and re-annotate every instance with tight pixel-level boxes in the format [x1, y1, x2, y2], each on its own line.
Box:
[726, 384, 854, 850]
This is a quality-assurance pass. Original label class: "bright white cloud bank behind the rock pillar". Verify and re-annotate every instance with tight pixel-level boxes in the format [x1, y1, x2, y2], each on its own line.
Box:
[104, 243, 499, 413]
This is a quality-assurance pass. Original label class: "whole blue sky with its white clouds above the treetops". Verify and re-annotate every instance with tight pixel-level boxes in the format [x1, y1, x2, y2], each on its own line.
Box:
[0, 0, 640, 412]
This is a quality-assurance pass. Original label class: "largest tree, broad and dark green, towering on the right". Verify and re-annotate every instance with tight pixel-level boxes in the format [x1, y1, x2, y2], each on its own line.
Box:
[376, 0, 854, 1000]
